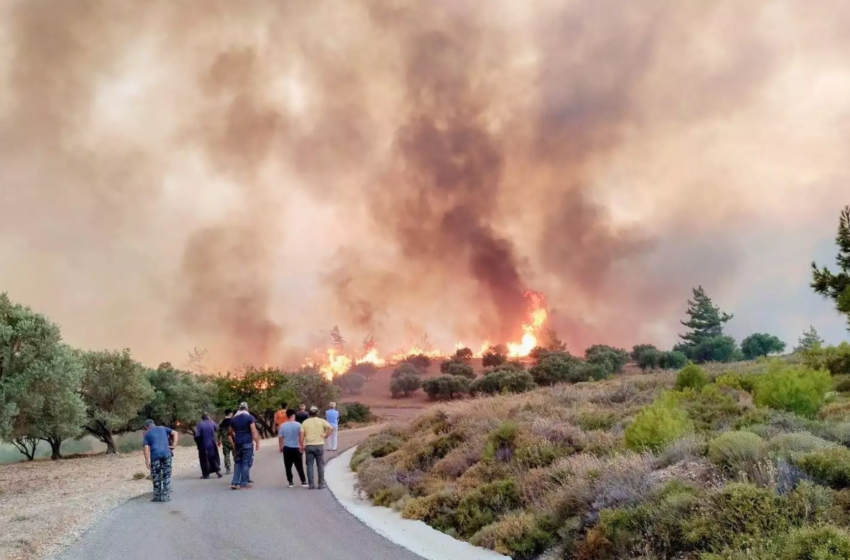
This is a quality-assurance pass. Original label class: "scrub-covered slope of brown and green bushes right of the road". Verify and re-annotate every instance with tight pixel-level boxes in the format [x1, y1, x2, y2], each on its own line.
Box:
[351, 354, 850, 560]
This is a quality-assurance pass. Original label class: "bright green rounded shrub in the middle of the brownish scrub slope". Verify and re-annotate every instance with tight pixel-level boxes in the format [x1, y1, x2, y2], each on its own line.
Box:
[625, 397, 692, 451]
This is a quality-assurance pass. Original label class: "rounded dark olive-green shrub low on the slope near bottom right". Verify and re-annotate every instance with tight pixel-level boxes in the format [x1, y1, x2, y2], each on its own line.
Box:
[685, 483, 788, 550]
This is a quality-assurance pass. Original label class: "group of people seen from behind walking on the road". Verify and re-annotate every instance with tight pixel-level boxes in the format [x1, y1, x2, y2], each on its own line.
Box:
[143, 402, 339, 502]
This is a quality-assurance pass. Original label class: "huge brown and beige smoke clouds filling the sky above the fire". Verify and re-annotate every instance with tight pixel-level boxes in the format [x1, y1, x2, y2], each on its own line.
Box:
[0, 0, 850, 364]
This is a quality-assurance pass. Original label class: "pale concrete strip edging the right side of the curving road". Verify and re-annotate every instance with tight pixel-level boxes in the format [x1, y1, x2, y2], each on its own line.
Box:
[325, 445, 510, 560]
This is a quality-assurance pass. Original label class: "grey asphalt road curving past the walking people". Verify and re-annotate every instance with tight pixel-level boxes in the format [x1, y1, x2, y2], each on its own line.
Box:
[58, 427, 422, 560]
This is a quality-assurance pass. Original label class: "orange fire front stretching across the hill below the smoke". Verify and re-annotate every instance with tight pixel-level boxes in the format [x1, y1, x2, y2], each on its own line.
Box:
[304, 290, 548, 379]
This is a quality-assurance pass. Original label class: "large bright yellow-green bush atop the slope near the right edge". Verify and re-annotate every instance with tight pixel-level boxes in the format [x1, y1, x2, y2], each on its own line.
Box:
[755, 361, 832, 418]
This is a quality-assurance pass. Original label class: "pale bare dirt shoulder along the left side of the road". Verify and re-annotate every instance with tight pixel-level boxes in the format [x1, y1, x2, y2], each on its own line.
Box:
[0, 447, 198, 560]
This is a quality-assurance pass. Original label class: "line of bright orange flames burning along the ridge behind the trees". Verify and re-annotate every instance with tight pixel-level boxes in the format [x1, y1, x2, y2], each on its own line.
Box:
[305, 291, 548, 379]
